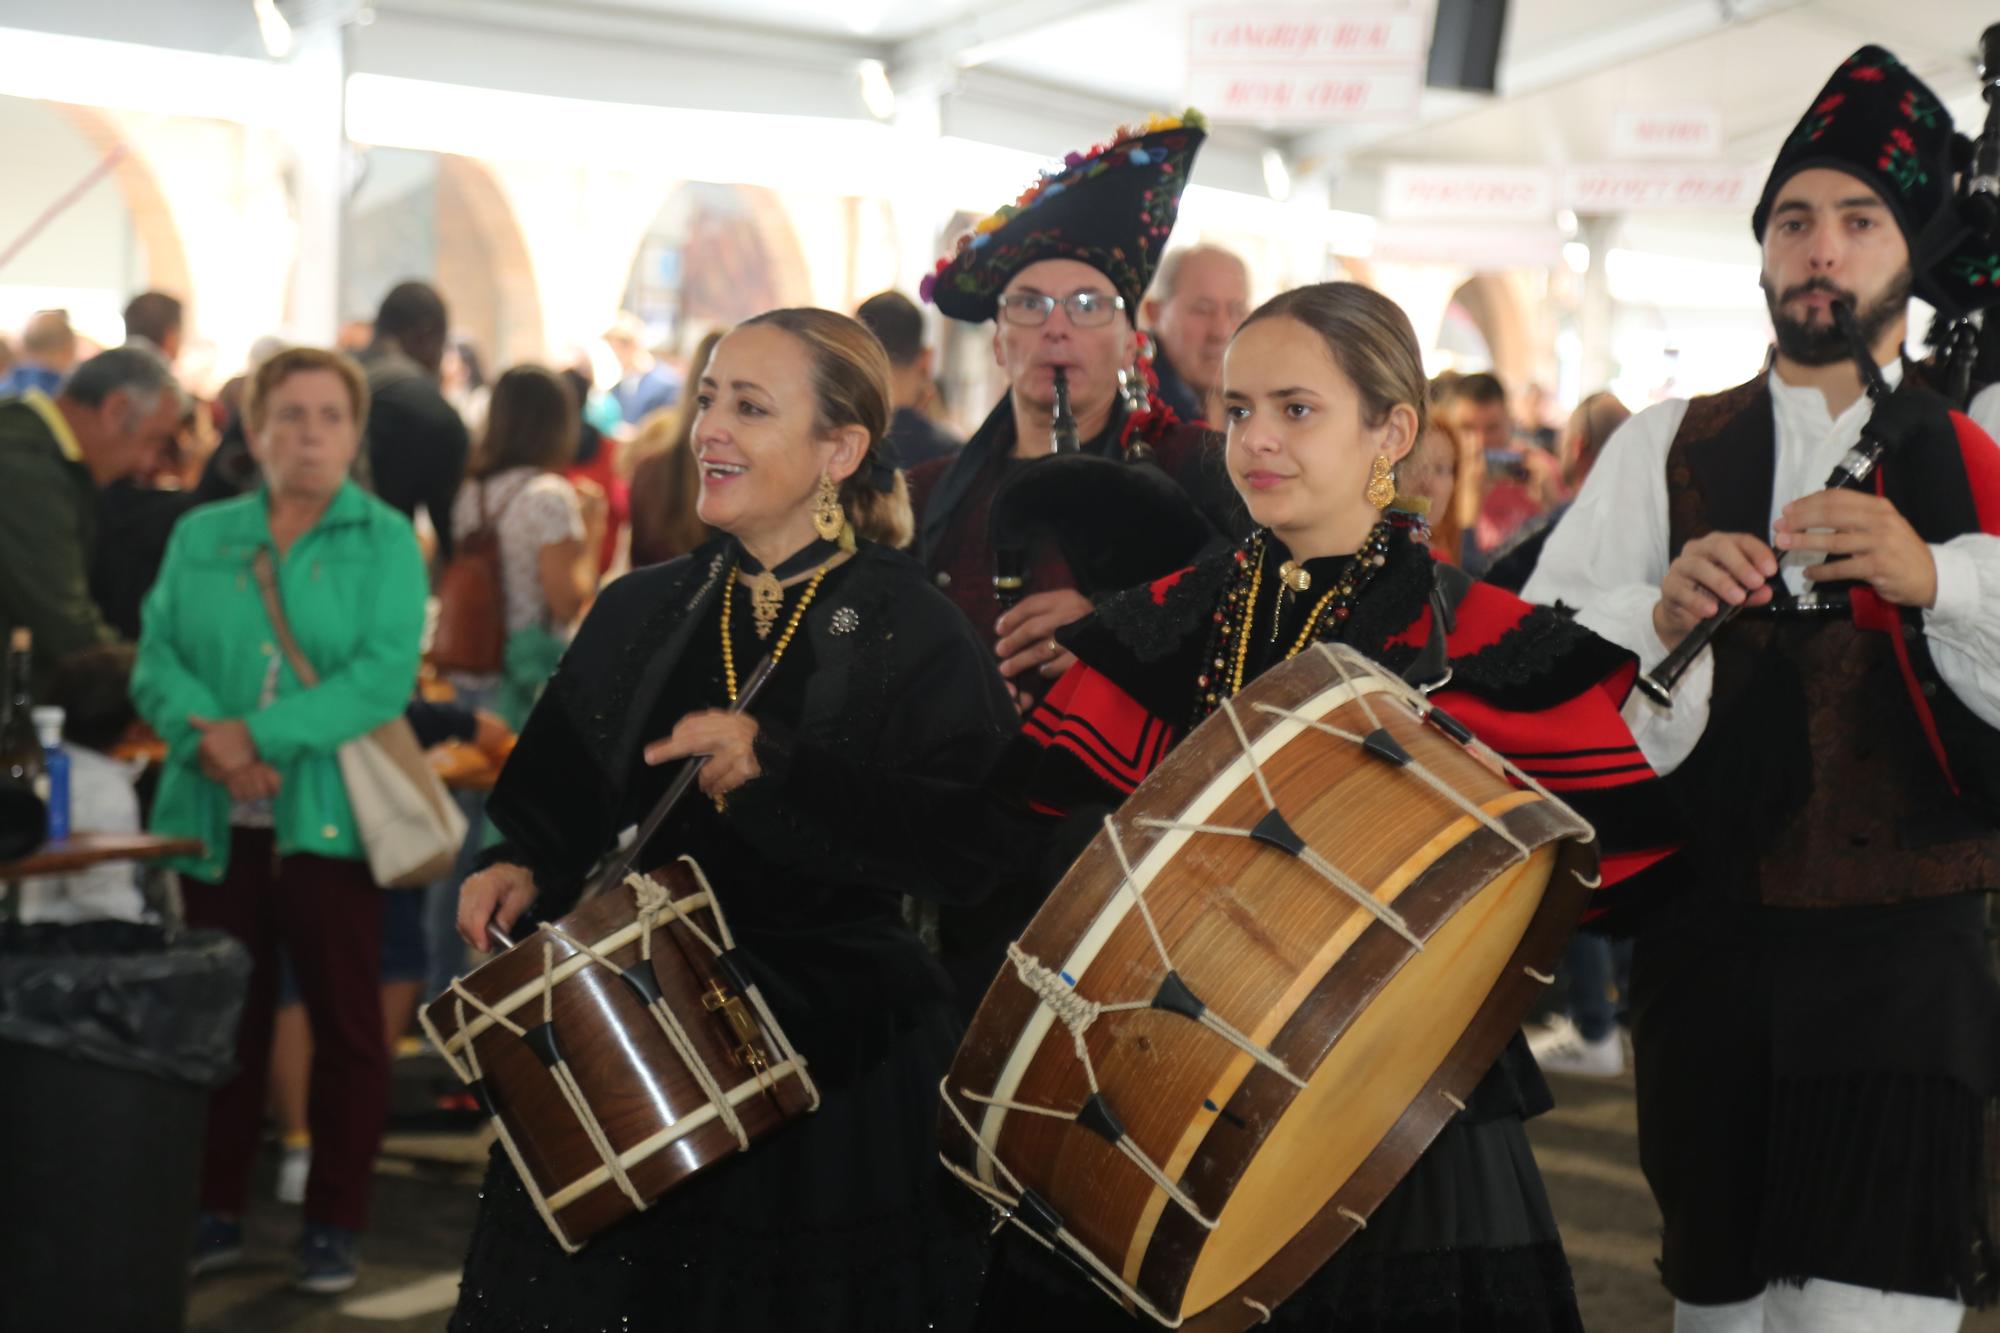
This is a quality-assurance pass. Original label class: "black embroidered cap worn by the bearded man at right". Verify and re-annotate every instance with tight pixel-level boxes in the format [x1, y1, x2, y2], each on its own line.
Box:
[1750, 46, 1952, 254]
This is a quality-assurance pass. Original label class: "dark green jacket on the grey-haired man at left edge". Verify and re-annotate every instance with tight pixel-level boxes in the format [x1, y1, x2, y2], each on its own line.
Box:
[0, 398, 118, 689]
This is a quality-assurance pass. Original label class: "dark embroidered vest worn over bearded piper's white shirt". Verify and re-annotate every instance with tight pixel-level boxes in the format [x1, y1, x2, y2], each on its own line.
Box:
[1666, 374, 2000, 907]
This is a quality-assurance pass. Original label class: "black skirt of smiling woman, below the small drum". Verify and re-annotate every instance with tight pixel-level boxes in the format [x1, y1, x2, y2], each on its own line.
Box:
[450, 1007, 986, 1333]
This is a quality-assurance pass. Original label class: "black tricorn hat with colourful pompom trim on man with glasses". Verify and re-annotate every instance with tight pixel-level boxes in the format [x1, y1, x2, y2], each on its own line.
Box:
[918, 108, 1206, 324]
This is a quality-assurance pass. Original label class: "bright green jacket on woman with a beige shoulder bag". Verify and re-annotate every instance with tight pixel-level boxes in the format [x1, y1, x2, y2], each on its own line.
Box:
[132, 482, 430, 881]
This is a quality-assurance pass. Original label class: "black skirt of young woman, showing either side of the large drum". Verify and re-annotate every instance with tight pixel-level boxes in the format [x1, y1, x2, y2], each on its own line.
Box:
[978, 1039, 1584, 1333]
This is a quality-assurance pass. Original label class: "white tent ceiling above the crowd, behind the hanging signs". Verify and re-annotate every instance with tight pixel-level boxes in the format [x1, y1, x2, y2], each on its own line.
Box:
[0, 0, 1994, 252]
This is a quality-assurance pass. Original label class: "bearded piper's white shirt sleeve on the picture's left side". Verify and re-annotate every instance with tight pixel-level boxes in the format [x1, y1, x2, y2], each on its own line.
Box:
[1522, 398, 1714, 773]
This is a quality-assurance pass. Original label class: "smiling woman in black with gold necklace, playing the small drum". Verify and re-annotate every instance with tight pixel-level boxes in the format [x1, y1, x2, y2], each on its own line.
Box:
[452, 310, 1014, 1333]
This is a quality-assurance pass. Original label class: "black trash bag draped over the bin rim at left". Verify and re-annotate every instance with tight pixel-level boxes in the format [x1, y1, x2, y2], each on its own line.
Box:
[0, 921, 250, 1087]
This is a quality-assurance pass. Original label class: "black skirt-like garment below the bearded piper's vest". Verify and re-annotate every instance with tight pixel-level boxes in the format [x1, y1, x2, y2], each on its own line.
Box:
[1632, 897, 2000, 1305]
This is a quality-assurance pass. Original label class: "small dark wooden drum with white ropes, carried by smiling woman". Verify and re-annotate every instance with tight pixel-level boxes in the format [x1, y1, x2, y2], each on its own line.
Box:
[422, 857, 820, 1253]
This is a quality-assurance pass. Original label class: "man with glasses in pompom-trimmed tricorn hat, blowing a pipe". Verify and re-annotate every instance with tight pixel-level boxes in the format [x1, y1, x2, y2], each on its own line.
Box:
[910, 110, 1244, 712]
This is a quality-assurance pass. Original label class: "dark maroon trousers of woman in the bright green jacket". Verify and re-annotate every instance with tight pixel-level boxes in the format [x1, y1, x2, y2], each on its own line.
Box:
[182, 829, 390, 1231]
